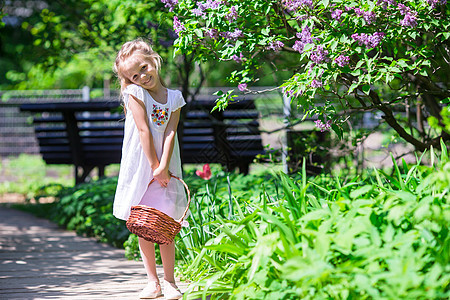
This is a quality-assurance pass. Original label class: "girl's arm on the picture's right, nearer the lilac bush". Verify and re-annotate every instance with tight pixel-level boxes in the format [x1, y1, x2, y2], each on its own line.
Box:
[153, 109, 181, 186]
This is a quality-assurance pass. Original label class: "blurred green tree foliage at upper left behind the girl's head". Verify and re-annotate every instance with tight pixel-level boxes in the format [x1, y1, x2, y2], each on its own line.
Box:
[0, 0, 176, 89]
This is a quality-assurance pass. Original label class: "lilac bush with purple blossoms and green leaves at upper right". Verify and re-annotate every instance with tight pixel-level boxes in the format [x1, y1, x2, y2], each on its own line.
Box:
[167, 0, 450, 150]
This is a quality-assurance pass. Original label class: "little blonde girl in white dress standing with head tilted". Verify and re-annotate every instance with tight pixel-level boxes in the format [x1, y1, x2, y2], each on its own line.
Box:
[114, 39, 187, 299]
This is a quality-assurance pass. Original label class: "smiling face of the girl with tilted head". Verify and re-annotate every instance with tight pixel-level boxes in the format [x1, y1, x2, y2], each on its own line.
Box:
[124, 55, 161, 90]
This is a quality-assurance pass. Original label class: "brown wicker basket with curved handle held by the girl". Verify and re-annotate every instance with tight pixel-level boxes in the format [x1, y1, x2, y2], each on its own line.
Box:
[127, 175, 191, 245]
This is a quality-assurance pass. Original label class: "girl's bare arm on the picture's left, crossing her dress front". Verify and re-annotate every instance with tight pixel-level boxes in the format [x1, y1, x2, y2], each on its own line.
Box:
[128, 95, 159, 170]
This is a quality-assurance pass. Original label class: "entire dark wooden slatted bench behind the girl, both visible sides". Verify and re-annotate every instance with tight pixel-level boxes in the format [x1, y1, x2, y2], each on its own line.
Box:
[20, 99, 263, 184]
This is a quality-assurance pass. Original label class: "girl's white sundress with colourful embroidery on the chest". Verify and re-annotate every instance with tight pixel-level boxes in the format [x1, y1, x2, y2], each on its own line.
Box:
[113, 84, 187, 220]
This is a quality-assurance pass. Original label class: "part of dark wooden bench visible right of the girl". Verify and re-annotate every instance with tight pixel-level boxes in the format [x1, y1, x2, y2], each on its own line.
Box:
[180, 97, 264, 174]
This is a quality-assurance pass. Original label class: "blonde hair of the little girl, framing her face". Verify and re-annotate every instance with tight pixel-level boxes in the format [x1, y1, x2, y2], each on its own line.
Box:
[113, 38, 165, 91]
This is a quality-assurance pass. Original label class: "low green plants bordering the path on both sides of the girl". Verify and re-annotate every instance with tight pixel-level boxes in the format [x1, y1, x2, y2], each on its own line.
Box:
[8, 148, 450, 299]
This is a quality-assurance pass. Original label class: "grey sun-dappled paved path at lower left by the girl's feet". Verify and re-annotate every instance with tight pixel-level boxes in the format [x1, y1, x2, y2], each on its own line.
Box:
[0, 206, 186, 299]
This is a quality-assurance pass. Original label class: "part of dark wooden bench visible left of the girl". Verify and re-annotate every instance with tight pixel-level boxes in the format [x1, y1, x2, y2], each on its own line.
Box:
[20, 101, 124, 184]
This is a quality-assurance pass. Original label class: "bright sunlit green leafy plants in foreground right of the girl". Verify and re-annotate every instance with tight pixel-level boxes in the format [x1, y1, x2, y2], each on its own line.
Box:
[178, 142, 450, 299]
